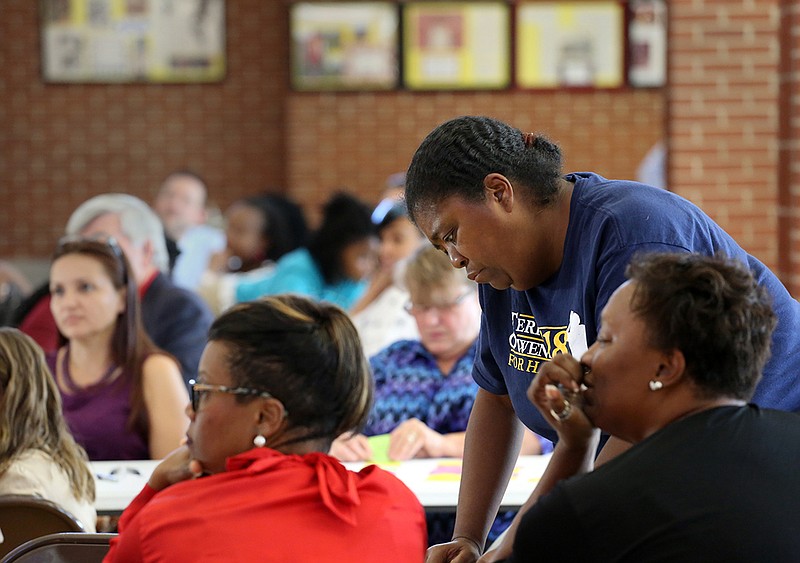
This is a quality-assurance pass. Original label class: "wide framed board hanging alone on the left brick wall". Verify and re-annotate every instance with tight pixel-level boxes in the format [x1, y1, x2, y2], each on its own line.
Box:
[40, 0, 225, 82]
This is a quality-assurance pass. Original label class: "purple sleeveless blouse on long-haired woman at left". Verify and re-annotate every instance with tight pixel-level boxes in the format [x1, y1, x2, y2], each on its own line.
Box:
[47, 353, 150, 461]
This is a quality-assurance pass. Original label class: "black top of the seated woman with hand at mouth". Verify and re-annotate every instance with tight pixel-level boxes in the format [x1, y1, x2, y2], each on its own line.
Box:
[508, 405, 800, 563]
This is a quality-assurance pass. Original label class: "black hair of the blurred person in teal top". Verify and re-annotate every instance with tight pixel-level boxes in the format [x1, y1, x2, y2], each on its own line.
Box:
[308, 192, 376, 283]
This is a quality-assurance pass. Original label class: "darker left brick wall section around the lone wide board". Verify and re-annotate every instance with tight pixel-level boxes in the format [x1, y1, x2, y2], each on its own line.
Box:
[0, 0, 288, 257]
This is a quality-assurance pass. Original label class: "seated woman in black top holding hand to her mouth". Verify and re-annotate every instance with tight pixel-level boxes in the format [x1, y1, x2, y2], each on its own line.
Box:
[510, 254, 800, 562]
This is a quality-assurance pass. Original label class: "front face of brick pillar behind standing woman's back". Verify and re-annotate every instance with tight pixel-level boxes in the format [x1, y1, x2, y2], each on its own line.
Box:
[667, 0, 781, 274]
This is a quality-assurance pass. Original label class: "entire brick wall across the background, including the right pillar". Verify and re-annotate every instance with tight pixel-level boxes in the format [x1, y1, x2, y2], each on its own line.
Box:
[0, 0, 800, 300]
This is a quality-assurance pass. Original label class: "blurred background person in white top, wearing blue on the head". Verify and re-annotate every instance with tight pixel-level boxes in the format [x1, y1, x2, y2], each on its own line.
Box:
[350, 200, 425, 357]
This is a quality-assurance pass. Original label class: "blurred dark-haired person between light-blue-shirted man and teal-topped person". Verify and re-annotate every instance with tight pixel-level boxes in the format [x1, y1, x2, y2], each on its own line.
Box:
[198, 195, 308, 315]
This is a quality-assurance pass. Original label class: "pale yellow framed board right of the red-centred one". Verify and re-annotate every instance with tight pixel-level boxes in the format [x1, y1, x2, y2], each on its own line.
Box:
[516, 1, 625, 88]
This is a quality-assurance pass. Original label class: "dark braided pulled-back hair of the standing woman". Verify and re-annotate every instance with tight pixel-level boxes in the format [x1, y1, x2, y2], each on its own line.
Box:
[405, 116, 561, 221]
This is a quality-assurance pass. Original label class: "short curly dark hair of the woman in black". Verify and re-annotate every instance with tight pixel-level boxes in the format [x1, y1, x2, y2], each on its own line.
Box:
[626, 253, 777, 400]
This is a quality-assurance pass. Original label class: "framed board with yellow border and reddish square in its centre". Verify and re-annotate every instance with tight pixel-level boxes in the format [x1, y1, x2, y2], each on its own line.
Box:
[403, 1, 511, 90]
